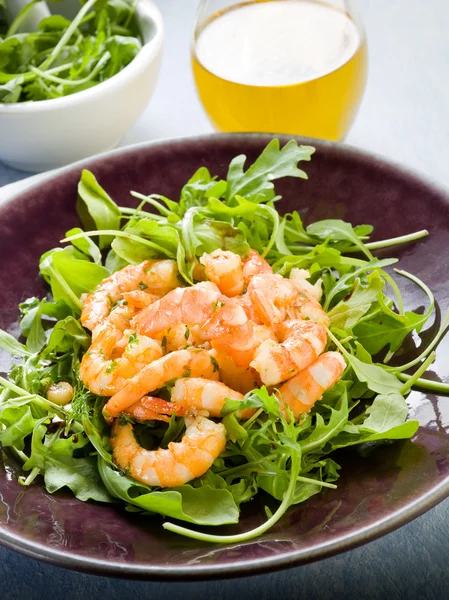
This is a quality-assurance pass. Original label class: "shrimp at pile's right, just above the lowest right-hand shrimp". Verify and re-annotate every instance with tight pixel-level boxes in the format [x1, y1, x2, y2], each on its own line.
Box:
[251, 320, 327, 385]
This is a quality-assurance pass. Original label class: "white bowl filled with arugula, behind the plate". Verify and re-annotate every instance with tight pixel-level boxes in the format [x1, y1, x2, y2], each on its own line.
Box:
[0, 0, 164, 172]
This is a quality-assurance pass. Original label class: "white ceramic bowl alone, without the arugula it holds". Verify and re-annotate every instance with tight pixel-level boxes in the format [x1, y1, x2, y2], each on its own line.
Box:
[0, 0, 164, 173]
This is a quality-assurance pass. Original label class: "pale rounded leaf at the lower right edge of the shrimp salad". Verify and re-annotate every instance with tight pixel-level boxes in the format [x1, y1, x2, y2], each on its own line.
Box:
[360, 392, 408, 433]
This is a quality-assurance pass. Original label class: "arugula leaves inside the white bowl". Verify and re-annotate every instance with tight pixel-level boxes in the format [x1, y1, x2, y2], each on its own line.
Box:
[0, 0, 142, 103]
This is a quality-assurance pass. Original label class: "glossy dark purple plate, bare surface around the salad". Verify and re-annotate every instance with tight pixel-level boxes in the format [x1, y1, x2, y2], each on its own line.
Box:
[0, 134, 449, 580]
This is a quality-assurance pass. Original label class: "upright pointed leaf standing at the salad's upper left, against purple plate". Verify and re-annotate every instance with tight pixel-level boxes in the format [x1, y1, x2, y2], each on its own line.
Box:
[76, 169, 121, 249]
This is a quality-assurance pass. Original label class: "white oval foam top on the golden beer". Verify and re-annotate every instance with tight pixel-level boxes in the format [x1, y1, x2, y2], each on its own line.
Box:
[195, 0, 361, 86]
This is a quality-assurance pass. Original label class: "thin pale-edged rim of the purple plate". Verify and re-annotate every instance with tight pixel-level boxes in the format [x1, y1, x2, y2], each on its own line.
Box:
[0, 133, 449, 581]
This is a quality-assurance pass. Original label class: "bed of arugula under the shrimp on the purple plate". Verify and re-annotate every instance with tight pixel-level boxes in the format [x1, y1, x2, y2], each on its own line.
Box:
[0, 140, 449, 543]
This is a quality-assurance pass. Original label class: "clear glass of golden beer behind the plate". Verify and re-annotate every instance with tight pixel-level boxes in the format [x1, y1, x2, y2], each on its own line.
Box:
[192, 0, 367, 140]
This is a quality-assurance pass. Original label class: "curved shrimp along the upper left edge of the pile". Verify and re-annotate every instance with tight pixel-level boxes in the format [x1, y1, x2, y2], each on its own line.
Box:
[81, 260, 179, 331]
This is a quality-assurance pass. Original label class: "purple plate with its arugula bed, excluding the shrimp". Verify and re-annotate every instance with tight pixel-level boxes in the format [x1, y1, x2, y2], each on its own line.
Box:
[0, 134, 449, 580]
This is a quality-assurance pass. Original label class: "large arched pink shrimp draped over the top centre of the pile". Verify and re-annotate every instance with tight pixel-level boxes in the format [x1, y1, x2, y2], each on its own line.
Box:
[133, 283, 254, 364]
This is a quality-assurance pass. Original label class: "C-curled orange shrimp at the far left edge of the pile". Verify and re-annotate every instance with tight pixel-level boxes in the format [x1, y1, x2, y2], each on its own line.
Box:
[80, 325, 162, 396]
